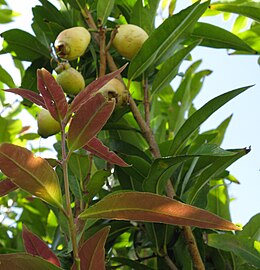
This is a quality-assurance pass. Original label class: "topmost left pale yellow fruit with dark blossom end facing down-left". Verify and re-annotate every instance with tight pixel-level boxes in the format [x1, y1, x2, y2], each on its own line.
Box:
[54, 26, 91, 61]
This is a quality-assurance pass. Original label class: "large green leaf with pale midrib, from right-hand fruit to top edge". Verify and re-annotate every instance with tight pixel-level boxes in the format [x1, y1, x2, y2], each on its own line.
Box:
[128, 1, 209, 80]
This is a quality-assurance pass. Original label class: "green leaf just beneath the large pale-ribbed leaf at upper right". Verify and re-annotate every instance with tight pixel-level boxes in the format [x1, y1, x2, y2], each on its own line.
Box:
[151, 42, 200, 94]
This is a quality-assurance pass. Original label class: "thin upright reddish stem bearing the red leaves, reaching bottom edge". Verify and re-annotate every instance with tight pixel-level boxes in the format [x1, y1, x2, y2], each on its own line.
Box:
[61, 125, 80, 270]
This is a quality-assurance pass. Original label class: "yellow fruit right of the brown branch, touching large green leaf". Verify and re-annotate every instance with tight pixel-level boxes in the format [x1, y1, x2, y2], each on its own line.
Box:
[112, 24, 148, 60]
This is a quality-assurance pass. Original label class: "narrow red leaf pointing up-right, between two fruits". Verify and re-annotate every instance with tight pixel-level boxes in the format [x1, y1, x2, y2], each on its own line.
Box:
[69, 64, 127, 113]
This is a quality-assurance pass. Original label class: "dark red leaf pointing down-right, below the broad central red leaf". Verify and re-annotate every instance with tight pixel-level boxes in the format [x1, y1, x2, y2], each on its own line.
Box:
[83, 137, 130, 167]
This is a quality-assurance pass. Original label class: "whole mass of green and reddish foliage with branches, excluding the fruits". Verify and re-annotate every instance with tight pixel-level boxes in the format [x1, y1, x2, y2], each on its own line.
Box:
[0, 0, 260, 270]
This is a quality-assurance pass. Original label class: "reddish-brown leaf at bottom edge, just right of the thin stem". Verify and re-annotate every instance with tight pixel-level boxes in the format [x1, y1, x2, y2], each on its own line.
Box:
[71, 226, 110, 270]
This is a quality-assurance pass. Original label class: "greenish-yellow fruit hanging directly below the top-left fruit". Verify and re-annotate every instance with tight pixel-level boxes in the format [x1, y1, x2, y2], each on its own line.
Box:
[55, 63, 85, 95]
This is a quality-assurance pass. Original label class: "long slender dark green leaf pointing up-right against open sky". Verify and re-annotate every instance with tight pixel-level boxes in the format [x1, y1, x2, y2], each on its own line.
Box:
[168, 86, 251, 156]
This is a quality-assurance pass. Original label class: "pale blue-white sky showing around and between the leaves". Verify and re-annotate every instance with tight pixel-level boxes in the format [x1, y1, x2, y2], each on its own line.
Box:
[0, 0, 260, 225]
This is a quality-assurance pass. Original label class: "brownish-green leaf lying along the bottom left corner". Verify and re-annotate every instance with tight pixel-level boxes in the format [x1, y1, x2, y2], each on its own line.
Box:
[0, 253, 62, 270]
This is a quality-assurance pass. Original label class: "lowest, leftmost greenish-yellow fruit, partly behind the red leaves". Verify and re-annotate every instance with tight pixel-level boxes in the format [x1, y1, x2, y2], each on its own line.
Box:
[37, 109, 60, 138]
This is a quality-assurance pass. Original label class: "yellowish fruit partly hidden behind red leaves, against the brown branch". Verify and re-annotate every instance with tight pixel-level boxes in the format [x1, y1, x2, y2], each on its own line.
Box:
[99, 78, 128, 106]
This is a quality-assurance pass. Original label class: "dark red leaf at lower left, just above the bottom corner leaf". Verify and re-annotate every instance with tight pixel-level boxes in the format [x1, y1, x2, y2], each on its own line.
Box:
[22, 225, 61, 266]
